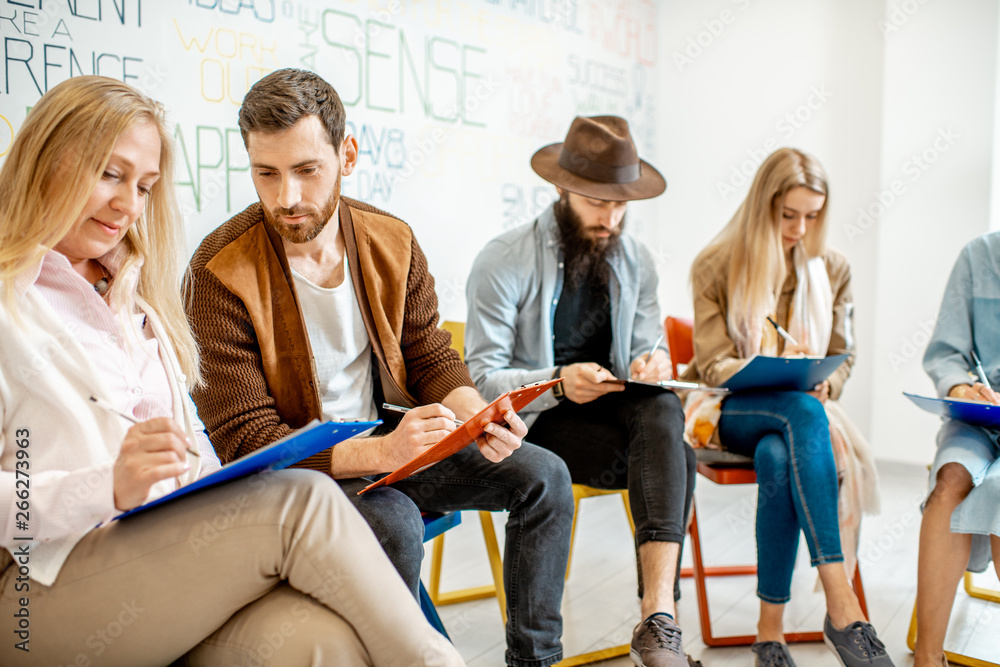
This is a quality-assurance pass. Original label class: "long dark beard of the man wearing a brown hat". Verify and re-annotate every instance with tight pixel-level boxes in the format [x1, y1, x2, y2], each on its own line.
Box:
[552, 195, 625, 290]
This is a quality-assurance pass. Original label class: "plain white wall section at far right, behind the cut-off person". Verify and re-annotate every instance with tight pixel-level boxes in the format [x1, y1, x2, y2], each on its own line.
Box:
[871, 0, 998, 462]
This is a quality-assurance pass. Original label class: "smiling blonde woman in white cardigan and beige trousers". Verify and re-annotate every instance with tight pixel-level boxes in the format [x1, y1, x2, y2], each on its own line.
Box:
[0, 76, 462, 667]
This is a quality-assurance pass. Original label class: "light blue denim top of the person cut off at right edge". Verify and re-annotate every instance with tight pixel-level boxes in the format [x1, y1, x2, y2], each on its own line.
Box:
[924, 232, 1000, 397]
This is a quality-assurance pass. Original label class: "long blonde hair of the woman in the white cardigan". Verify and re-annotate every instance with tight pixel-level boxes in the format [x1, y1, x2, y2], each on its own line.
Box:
[0, 76, 200, 383]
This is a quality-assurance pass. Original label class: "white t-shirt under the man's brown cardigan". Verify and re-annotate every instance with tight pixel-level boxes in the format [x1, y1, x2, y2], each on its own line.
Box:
[292, 256, 378, 421]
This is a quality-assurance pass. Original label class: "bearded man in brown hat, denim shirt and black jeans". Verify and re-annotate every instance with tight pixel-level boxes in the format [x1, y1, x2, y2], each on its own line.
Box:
[465, 116, 696, 667]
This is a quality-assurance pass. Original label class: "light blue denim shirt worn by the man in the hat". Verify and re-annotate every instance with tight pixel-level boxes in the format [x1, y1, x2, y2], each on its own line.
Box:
[465, 206, 666, 426]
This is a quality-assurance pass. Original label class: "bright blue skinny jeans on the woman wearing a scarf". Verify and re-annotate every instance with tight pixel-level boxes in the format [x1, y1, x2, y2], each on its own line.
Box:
[719, 391, 844, 604]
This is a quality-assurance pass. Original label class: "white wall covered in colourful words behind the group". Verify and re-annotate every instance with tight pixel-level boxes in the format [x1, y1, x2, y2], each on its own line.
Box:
[0, 0, 658, 310]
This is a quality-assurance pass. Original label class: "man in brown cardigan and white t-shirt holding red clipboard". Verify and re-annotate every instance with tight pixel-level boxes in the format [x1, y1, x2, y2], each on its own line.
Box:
[186, 69, 573, 667]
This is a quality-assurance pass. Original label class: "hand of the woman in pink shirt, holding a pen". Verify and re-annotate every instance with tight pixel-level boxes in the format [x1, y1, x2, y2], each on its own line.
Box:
[114, 417, 190, 511]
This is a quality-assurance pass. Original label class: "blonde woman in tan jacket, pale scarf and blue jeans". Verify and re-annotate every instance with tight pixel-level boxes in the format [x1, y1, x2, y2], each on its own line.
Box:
[685, 148, 892, 667]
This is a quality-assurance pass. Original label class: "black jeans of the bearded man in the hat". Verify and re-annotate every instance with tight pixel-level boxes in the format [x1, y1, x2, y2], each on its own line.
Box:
[527, 387, 697, 580]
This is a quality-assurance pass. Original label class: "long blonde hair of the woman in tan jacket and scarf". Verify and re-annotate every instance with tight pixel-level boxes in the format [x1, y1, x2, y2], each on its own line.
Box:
[694, 148, 830, 350]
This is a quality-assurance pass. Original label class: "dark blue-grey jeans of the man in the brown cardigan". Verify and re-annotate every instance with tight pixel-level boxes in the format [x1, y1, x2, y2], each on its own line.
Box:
[338, 443, 573, 667]
